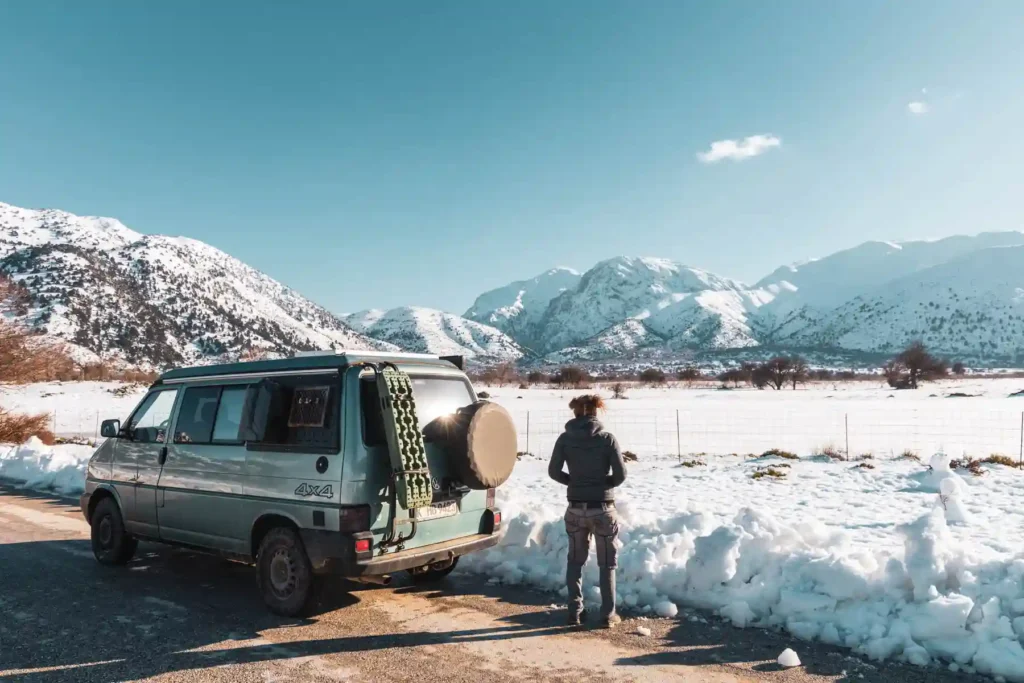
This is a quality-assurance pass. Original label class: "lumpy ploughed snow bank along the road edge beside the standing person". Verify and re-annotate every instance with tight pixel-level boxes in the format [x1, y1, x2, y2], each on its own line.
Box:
[464, 483, 1024, 681]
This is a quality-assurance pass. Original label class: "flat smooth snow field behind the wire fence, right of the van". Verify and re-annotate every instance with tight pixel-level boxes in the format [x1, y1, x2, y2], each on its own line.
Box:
[489, 379, 1024, 459]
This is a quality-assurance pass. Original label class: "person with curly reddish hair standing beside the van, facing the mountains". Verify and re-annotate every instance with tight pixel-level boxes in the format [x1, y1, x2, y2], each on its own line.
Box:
[548, 394, 626, 629]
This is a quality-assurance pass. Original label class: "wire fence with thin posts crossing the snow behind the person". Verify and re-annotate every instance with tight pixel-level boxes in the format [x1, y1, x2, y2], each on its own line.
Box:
[512, 404, 1024, 462]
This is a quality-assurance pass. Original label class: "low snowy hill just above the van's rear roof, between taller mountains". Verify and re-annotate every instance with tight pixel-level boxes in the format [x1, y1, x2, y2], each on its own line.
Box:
[342, 307, 522, 364]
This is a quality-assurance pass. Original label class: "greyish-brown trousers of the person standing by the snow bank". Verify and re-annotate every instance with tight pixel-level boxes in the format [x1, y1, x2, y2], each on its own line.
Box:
[565, 504, 618, 618]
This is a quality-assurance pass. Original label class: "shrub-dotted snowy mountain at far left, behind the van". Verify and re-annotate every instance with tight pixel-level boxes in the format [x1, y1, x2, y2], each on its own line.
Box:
[0, 203, 393, 367]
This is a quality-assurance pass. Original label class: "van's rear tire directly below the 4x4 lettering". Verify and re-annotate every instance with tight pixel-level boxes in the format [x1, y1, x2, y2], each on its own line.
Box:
[256, 526, 314, 616]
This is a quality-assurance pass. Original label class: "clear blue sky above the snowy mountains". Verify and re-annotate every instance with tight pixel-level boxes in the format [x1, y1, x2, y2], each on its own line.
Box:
[0, 0, 1024, 312]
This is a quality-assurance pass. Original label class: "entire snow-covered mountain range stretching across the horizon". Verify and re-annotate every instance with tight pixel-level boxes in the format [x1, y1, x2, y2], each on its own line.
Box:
[6, 197, 1024, 367]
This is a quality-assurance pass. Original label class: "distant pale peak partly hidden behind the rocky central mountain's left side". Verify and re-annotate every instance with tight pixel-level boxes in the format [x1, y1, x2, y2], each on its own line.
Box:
[464, 267, 581, 345]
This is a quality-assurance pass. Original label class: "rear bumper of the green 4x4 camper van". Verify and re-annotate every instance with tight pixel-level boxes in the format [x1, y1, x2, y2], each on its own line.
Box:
[299, 509, 502, 577]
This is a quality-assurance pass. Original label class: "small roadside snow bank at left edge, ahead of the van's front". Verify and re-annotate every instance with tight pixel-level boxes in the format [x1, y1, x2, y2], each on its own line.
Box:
[0, 436, 94, 496]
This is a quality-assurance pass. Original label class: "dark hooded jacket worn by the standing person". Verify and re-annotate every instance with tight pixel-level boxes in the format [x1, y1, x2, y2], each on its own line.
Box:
[548, 416, 626, 503]
